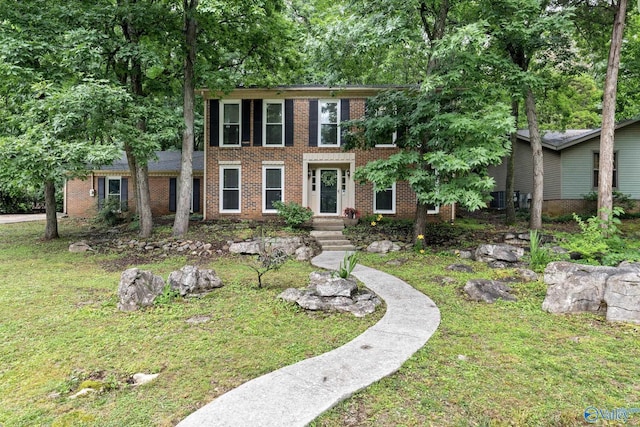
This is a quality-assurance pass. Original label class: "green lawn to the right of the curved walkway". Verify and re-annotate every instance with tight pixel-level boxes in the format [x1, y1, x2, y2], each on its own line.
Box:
[313, 254, 640, 426]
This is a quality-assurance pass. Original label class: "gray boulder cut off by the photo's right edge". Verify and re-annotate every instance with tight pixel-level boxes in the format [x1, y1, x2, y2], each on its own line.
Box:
[604, 272, 640, 323]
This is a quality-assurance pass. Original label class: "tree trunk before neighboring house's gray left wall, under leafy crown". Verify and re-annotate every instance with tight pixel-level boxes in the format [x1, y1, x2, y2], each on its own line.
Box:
[524, 88, 544, 230]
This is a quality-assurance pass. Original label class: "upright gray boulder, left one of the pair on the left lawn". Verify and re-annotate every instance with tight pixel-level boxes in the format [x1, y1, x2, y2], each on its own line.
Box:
[118, 268, 164, 311]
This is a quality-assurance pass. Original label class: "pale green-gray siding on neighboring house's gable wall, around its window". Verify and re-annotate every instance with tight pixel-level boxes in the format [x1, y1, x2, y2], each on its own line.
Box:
[562, 123, 640, 199]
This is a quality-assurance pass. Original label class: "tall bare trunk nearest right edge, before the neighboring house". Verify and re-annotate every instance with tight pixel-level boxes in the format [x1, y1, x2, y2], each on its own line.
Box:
[598, 0, 627, 221]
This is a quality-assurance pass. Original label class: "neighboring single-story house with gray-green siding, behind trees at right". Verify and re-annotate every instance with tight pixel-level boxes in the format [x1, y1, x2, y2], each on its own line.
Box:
[489, 118, 640, 216]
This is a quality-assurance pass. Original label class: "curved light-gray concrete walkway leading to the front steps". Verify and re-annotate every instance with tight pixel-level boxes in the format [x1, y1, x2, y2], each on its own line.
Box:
[178, 251, 440, 427]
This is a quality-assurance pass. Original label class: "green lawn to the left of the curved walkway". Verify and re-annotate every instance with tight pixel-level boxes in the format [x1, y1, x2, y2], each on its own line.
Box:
[0, 221, 383, 427]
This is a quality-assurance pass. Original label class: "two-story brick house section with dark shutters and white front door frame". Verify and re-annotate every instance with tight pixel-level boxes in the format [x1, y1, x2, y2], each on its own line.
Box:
[200, 86, 453, 220]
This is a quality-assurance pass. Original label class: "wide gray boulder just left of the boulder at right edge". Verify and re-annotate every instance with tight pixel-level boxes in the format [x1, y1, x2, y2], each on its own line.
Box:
[542, 261, 619, 313]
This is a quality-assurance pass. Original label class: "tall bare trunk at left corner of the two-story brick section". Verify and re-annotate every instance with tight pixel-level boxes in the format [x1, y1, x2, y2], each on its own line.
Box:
[173, 0, 198, 237]
